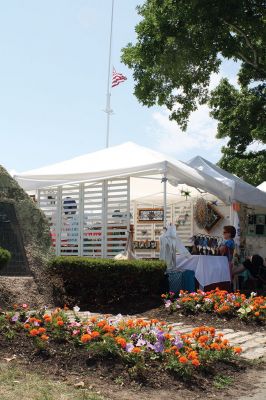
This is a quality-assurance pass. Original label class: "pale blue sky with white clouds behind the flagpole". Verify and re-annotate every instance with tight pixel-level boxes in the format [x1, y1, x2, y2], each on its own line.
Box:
[0, 0, 237, 172]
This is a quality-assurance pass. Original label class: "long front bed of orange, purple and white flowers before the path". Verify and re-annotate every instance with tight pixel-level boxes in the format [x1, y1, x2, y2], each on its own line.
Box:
[0, 305, 241, 375]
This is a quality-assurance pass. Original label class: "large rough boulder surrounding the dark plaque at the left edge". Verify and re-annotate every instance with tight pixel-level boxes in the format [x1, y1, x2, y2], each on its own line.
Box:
[0, 166, 52, 307]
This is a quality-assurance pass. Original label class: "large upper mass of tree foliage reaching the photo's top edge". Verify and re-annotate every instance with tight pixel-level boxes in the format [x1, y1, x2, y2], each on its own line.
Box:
[122, 0, 266, 130]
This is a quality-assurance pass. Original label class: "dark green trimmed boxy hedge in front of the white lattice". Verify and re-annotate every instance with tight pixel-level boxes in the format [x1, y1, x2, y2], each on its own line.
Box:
[50, 256, 166, 306]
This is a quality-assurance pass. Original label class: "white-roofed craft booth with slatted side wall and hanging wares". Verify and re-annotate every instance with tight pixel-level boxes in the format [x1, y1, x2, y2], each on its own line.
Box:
[15, 142, 266, 286]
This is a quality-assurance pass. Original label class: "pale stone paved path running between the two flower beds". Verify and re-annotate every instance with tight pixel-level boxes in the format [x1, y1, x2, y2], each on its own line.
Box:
[68, 311, 266, 360]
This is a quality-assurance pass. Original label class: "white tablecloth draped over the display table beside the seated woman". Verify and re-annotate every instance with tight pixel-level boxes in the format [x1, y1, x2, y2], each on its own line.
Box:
[174, 255, 231, 288]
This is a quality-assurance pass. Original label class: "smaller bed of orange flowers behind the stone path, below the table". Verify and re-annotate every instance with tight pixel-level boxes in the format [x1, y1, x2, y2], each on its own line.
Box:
[162, 288, 266, 323]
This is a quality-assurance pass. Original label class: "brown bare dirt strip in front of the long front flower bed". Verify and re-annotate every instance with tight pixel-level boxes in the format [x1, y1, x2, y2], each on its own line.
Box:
[0, 335, 263, 400]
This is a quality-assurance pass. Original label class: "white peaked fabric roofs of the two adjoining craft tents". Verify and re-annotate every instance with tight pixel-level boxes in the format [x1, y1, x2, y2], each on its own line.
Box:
[15, 142, 266, 205]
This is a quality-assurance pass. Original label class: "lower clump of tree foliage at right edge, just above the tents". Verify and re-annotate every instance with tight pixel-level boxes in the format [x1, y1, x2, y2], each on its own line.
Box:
[209, 79, 266, 185]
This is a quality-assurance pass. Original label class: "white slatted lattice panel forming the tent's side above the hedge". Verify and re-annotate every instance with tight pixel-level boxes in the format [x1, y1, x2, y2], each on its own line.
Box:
[38, 179, 130, 257]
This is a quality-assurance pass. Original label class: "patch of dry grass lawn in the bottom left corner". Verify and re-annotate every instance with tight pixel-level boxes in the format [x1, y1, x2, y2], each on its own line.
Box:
[0, 362, 104, 400]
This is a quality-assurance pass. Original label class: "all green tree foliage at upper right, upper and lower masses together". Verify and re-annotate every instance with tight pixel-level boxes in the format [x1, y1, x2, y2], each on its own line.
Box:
[122, 0, 266, 183]
